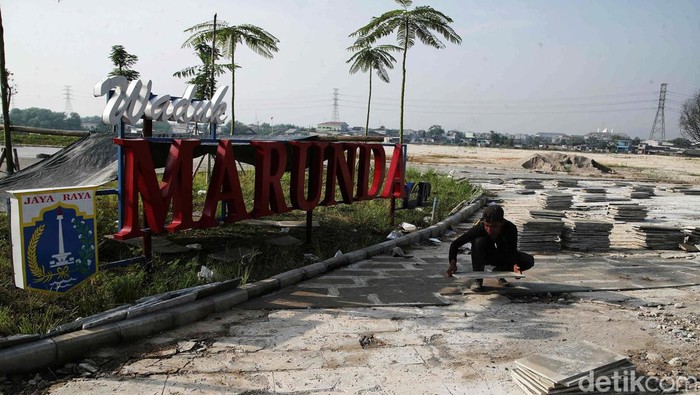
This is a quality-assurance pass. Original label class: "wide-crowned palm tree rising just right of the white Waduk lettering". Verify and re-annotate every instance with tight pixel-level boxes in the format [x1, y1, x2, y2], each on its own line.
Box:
[182, 21, 279, 131]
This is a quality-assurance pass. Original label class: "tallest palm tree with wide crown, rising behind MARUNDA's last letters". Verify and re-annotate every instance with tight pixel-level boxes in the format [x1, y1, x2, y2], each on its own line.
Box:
[350, 0, 462, 143]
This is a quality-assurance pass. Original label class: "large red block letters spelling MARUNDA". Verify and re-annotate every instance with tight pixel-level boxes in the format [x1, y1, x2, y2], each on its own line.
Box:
[114, 138, 405, 239]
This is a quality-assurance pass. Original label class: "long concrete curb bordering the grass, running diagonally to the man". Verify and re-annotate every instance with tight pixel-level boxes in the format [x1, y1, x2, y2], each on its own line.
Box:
[0, 196, 486, 374]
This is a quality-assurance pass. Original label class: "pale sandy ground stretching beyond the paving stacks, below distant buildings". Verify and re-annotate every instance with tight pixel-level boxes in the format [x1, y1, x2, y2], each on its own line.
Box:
[408, 144, 700, 185]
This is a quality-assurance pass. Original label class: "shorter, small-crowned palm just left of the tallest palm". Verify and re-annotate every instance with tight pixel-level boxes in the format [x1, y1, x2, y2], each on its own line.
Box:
[345, 44, 401, 136]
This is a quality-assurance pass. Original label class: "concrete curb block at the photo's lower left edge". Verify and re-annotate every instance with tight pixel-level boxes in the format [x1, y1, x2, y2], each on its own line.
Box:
[0, 338, 58, 374]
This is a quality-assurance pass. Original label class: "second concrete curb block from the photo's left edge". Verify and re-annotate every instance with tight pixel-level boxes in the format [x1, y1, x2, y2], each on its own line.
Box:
[53, 324, 122, 363]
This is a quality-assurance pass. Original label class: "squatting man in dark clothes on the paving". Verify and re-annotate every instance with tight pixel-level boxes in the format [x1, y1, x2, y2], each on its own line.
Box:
[445, 204, 535, 292]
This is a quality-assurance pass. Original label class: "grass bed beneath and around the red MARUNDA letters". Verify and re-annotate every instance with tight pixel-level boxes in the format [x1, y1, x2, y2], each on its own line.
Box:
[0, 168, 481, 336]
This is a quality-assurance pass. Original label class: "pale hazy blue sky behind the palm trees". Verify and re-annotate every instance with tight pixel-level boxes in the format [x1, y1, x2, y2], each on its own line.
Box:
[2, 0, 700, 138]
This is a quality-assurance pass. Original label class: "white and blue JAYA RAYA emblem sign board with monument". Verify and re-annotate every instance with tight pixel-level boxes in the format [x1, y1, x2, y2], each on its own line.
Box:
[8, 186, 97, 293]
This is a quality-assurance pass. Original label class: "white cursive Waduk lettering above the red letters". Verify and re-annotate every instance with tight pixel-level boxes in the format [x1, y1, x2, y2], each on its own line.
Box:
[94, 75, 228, 125]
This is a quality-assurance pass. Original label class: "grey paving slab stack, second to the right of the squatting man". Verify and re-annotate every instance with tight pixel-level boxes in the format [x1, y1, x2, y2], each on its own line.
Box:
[562, 218, 613, 251]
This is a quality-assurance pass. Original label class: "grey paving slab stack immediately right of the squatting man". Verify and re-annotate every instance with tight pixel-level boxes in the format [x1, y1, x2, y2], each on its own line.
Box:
[513, 218, 564, 253]
